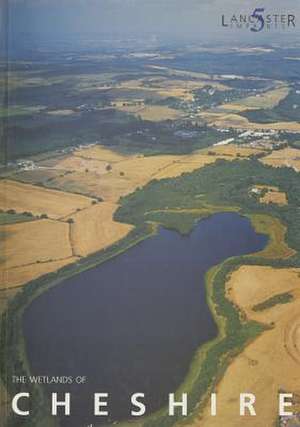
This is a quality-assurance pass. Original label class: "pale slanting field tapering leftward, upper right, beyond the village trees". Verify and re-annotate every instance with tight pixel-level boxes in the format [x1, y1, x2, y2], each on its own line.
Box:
[221, 86, 290, 112]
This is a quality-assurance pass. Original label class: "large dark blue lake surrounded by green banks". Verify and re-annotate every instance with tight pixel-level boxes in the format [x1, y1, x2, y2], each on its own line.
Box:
[24, 213, 267, 427]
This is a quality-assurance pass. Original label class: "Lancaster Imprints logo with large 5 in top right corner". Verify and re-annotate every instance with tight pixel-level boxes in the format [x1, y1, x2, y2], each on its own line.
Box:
[222, 7, 296, 33]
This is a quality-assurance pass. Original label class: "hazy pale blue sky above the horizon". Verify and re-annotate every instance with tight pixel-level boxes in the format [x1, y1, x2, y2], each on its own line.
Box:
[4, 0, 300, 42]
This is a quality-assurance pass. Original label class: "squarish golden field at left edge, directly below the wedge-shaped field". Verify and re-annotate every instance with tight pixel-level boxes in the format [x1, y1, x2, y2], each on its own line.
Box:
[0, 219, 72, 269]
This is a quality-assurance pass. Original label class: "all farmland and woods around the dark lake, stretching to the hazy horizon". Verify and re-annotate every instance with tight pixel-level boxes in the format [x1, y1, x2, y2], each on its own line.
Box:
[0, 41, 300, 427]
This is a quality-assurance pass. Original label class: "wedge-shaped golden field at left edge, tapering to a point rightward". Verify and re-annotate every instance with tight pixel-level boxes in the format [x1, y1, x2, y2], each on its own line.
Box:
[0, 180, 91, 219]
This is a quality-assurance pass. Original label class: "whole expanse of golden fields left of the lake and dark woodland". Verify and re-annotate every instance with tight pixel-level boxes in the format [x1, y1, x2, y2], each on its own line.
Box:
[0, 145, 263, 294]
